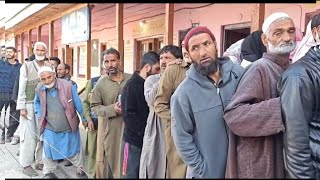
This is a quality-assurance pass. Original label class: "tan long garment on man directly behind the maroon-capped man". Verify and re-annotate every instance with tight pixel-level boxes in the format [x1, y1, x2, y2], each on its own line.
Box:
[154, 61, 189, 178]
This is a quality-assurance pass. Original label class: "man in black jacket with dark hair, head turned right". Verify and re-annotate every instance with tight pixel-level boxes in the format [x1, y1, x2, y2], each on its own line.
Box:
[120, 51, 160, 179]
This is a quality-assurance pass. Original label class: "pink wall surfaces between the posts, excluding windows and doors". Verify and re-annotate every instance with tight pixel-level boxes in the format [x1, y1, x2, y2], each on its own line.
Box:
[15, 3, 320, 77]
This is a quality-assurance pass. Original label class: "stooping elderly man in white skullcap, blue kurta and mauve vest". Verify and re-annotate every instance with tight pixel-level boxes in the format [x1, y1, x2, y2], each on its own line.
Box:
[34, 66, 87, 178]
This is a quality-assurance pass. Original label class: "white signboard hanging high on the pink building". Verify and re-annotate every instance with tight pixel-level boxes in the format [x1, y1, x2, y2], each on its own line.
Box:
[61, 7, 90, 44]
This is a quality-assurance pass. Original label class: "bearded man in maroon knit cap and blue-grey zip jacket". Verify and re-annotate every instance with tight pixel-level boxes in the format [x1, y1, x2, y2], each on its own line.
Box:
[168, 26, 243, 178]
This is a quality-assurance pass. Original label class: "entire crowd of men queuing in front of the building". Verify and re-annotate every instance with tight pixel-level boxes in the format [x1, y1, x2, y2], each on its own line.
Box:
[0, 12, 320, 180]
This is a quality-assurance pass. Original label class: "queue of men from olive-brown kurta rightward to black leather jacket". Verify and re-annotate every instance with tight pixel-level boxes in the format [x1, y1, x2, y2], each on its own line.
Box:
[86, 12, 320, 179]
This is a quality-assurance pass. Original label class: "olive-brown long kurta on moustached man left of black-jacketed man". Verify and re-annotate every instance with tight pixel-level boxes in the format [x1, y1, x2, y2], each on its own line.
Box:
[90, 73, 131, 178]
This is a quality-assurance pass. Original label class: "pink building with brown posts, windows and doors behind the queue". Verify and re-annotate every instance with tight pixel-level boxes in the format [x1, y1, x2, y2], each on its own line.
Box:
[6, 3, 320, 88]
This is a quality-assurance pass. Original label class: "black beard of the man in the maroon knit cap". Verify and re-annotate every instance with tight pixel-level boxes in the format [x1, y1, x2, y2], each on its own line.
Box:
[193, 58, 220, 76]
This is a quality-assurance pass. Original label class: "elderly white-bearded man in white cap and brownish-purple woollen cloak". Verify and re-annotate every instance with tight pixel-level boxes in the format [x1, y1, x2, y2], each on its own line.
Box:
[224, 12, 296, 178]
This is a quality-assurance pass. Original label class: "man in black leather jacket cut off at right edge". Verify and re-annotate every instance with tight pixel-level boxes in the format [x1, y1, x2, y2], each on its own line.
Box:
[278, 15, 320, 180]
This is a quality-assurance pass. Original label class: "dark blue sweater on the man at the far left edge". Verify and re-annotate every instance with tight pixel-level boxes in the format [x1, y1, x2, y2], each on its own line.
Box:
[0, 60, 21, 93]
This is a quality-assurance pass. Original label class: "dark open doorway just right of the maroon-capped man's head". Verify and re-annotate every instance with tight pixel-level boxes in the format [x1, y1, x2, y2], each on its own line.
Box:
[220, 23, 251, 55]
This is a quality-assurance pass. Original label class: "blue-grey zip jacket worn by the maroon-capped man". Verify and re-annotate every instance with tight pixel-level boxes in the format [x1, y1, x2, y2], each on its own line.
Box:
[171, 59, 243, 178]
